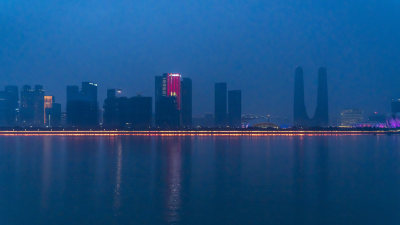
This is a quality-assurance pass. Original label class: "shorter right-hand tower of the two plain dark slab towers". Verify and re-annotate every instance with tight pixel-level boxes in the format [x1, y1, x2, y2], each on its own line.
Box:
[228, 90, 242, 128]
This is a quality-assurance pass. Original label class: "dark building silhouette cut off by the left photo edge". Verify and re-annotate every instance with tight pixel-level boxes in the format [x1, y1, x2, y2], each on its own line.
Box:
[0, 86, 19, 127]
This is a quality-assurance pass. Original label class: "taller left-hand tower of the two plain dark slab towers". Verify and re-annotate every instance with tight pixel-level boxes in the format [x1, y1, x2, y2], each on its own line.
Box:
[214, 83, 227, 127]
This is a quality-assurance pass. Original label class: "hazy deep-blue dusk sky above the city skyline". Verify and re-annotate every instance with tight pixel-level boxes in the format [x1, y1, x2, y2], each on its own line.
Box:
[0, 0, 400, 117]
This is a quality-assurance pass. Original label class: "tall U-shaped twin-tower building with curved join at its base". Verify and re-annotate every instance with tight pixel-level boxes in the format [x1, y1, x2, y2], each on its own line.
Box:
[293, 67, 329, 127]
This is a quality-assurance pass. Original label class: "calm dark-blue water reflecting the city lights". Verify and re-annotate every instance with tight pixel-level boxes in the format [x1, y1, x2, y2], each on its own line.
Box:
[0, 136, 400, 225]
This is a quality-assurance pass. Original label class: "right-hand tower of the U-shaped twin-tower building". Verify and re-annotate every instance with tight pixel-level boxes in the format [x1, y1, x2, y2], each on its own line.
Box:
[312, 67, 329, 127]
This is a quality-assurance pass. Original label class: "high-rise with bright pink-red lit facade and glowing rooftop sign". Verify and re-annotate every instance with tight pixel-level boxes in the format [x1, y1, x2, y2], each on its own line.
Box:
[155, 73, 182, 128]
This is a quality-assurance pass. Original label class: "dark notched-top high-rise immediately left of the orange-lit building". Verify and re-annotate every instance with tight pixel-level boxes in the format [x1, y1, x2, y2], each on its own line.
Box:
[20, 85, 44, 127]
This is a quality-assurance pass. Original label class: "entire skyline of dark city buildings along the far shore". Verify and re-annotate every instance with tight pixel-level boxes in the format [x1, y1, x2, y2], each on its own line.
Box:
[0, 67, 400, 129]
